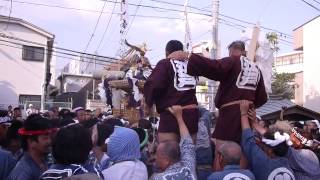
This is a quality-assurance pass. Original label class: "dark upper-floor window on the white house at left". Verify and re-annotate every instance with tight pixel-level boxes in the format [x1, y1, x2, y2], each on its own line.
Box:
[22, 46, 44, 61]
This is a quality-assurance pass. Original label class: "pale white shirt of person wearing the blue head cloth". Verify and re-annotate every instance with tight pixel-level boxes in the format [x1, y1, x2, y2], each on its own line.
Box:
[102, 160, 148, 180]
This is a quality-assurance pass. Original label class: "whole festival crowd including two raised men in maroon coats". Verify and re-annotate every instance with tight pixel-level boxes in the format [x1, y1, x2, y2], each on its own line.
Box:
[0, 41, 320, 180]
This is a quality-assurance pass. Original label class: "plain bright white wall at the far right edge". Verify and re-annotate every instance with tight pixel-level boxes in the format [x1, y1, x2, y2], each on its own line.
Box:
[303, 17, 320, 112]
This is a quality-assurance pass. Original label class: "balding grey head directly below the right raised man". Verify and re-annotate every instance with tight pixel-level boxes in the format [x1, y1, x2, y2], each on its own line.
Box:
[218, 141, 241, 168]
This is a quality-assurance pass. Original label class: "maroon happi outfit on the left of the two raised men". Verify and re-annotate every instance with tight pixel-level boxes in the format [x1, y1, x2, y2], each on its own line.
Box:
[143, 59, 199, 134]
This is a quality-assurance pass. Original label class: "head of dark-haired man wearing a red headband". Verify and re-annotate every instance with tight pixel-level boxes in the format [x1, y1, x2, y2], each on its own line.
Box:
[18, 114, 56, 154]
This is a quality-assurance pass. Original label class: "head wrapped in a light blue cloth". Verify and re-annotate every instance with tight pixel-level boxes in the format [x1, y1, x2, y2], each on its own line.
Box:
[107, 126, 141, 162]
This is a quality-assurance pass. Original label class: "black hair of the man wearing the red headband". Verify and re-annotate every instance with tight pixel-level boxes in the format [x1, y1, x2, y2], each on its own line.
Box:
[21, 114, 52, 151]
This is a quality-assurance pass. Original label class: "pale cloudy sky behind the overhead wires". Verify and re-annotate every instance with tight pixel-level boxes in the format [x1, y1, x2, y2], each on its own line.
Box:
[0, 0, 320, 70]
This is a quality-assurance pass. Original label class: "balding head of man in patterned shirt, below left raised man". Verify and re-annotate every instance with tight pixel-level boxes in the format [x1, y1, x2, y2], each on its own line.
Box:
[156, 141, 181, 171]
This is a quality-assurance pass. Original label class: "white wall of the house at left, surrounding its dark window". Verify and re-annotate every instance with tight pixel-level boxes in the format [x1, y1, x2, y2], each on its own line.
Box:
[0, 22, 50, 105]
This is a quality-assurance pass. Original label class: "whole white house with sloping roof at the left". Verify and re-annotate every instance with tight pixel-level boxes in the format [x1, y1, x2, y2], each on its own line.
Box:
[0, 16, 55, 109]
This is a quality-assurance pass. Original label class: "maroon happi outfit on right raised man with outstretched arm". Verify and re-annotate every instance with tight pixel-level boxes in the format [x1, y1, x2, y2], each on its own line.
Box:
[187, 54, 268, 142]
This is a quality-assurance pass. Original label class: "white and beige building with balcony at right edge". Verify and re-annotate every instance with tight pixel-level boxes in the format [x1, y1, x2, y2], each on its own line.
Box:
[275, 16, 320, 112]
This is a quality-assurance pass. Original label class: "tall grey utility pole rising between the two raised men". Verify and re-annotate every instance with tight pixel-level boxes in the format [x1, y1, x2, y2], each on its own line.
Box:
[208, 0, 219, 112]
